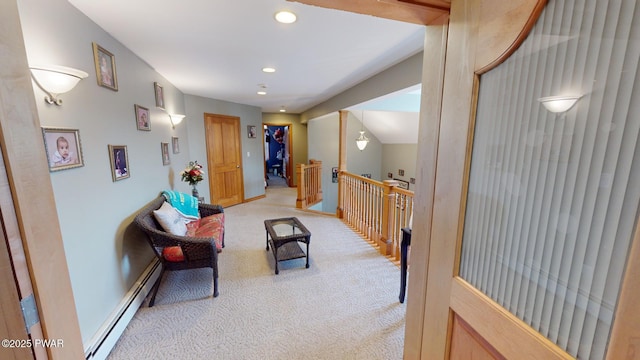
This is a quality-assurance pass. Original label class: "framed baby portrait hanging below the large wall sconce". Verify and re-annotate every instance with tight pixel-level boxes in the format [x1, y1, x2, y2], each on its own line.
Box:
[42, 127, 84, 171]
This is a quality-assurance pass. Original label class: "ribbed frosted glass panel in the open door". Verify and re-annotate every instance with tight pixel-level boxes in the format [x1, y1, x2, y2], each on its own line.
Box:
[460, 0, 640, 359]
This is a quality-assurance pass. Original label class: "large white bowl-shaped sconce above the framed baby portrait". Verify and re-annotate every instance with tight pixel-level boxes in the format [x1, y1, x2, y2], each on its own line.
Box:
[30, 65, 89, 106]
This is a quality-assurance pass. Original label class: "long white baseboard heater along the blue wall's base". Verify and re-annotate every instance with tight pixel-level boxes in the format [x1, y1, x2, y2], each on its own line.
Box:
[84, 259, 160, 360]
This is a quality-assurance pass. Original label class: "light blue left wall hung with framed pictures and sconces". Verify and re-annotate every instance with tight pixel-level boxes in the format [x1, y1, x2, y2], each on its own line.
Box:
[18, 0, 264, 345]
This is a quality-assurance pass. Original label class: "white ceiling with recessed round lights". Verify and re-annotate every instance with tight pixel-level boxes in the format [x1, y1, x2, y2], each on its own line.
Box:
[69, 0, 424, 143]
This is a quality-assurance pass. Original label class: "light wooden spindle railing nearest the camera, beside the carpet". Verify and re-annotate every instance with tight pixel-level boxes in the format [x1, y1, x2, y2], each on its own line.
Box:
[338, 171, 413, 261]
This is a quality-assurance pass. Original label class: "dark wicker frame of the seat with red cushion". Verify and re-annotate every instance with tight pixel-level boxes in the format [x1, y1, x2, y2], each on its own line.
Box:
[133, 195, 224, 307]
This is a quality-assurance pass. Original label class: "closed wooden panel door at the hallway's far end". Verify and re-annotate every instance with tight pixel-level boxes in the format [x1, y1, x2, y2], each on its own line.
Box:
[204, 114, 244, 207]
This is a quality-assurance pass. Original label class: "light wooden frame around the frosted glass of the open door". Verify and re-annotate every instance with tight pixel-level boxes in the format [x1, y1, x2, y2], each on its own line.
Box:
[405, 0, 640, 359]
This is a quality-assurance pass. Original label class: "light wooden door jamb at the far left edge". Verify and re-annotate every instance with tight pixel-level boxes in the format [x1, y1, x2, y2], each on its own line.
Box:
[0, 0, 84, 359]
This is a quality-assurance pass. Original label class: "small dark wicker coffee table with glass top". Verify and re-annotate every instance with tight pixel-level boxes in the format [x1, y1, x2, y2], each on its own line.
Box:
[264, 217, 311, 275]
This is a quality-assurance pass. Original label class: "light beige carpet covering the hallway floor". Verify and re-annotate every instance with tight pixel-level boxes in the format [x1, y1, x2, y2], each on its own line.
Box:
[108, 188, 406, 360]
